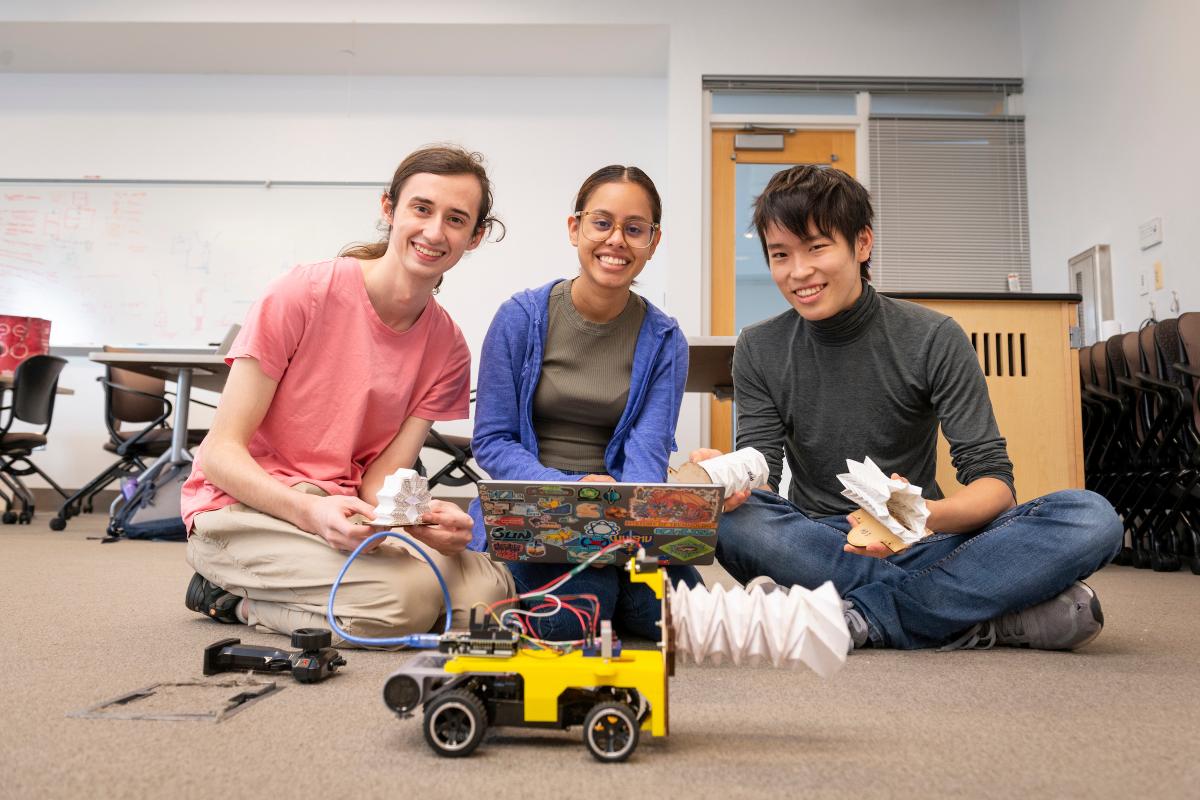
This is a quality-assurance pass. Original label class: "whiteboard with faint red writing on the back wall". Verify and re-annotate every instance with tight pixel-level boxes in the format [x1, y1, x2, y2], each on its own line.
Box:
[0, 182, 385, 347]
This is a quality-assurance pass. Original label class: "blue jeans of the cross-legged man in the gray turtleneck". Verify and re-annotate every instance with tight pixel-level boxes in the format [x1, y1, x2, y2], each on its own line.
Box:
[716, 489, 1122, 650]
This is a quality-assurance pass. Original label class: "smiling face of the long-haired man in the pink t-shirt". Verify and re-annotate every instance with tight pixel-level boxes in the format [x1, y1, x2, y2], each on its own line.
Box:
[383, 173, 484, 284]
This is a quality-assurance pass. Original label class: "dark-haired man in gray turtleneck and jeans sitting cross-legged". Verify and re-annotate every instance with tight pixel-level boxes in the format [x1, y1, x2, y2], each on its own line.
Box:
[692, 166, 1122, 650]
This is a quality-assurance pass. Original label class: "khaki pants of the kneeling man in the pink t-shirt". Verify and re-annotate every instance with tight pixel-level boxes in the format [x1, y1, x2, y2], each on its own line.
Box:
[187, 483, 515, 646]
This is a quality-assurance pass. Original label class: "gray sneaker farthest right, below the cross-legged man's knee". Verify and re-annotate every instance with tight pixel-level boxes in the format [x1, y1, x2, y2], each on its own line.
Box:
[942, 581, 1104, 651]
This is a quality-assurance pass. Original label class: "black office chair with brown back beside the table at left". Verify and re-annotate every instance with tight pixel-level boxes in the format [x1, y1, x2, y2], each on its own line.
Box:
[50, 347, 211, 530]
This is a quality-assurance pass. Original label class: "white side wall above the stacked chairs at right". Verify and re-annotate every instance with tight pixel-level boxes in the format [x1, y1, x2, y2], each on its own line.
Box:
[1021, 0, 1200, 331]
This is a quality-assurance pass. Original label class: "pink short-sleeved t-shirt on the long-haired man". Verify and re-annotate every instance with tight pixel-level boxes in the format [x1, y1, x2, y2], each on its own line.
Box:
[181, 258, 470, 531]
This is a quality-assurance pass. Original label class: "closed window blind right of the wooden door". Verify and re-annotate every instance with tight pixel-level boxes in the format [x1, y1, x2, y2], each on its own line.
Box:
[870, 118, 1032, 293]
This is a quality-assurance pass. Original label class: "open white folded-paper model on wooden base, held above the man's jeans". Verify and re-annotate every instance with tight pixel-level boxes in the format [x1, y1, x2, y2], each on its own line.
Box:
[838, 458, 929, 553]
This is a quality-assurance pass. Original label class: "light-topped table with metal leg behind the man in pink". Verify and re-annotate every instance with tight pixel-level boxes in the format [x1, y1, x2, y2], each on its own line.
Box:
[88, 349, 229, 473]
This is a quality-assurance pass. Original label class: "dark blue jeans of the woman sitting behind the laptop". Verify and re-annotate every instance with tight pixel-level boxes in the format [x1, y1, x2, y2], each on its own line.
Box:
[508, 561, 702, 642]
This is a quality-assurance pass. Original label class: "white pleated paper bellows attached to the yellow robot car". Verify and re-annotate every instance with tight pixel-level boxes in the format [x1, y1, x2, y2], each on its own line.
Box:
[671, 582, 850, 678]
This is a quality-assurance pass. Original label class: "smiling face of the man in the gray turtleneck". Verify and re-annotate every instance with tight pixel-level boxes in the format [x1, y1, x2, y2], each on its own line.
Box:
[764, 222, 875, 321]
